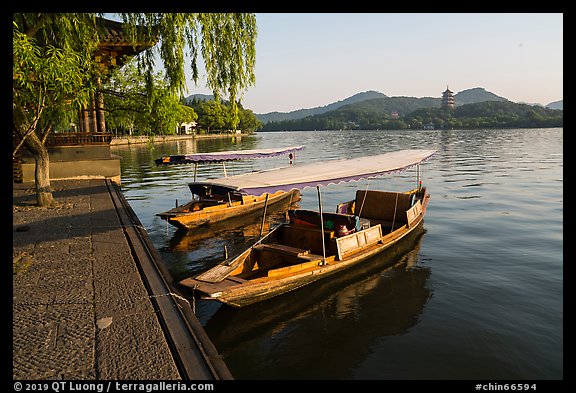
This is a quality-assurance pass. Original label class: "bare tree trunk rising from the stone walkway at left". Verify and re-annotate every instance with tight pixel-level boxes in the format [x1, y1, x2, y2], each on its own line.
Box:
[24, 133, 55, 206]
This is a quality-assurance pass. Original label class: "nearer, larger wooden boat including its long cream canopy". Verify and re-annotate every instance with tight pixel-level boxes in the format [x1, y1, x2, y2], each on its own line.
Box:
[180, 150, 435, 307]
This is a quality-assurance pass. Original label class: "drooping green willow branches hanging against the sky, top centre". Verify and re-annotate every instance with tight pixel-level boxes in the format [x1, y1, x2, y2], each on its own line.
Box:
[119, 13, 257, 106]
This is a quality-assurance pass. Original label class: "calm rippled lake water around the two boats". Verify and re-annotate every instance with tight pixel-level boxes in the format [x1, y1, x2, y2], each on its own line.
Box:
[112, 128, 564, 380]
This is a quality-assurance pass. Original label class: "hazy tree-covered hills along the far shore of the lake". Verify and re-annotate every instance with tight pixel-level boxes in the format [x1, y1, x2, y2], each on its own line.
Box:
[187, 87, 563, 131]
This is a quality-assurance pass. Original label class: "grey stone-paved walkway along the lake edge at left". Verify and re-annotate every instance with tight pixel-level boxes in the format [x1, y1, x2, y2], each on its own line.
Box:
[12, 180, 232, 380]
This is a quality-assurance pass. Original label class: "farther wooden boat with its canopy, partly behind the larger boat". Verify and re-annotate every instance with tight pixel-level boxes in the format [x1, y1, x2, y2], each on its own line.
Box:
[155, 146, 304, 230]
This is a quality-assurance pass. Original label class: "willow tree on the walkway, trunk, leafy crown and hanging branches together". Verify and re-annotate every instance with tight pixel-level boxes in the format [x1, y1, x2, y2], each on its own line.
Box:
[12, 13, 257, 206]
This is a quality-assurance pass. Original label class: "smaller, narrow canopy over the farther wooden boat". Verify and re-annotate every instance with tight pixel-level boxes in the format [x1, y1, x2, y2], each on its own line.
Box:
[154, 146, 304, 165]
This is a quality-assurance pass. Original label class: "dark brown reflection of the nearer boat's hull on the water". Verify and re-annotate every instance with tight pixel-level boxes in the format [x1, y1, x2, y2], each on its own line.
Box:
[204, 226, 431, 350]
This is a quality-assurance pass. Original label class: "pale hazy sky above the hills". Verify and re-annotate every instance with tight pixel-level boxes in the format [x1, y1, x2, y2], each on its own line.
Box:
[188, 13, 564, 113]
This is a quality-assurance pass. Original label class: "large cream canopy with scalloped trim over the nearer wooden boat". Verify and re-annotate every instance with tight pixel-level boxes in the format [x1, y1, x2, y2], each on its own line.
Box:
[212, 150, 436, 195]
